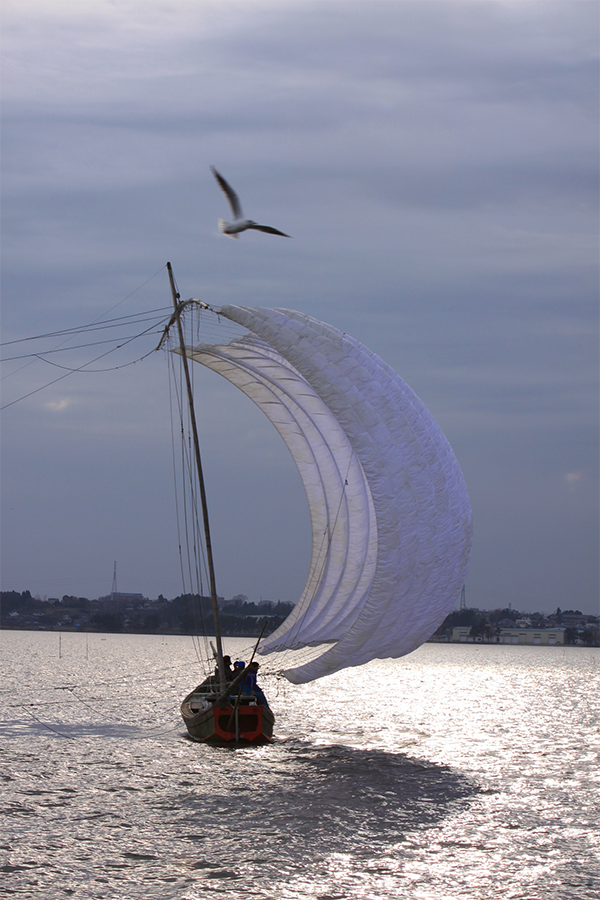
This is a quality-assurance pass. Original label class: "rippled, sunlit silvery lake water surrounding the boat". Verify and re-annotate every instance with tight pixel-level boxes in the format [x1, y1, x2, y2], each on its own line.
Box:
[0, 631, 600, 900]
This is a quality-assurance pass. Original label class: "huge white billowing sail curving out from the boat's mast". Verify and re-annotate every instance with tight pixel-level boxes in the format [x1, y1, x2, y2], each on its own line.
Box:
[187, 306, 472, 683]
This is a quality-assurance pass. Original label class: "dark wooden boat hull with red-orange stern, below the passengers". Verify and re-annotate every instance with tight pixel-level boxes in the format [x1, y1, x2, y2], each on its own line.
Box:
[181, 694, 275, 744]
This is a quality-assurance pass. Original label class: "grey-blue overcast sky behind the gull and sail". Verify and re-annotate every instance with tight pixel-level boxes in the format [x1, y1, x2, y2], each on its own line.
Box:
[0, 0, 600, 614]
